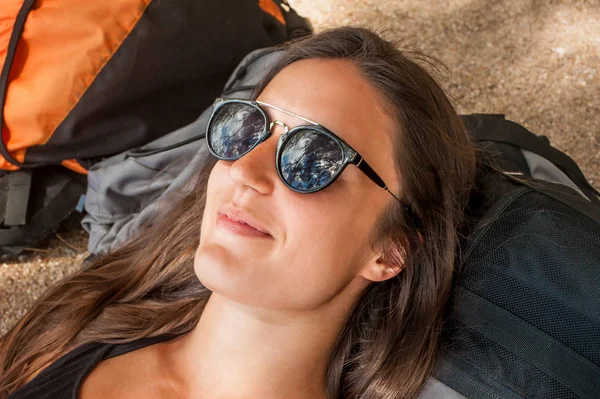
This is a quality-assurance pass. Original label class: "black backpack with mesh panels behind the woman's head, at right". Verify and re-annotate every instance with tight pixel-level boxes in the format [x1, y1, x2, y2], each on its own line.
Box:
[429, 115, 600, 399]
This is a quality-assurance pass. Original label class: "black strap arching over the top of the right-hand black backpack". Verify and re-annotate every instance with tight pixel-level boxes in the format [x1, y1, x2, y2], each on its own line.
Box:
[463, 114, 600, 204]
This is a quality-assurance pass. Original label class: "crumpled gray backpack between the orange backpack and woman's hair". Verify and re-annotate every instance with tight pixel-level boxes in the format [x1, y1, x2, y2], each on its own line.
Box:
[82, 47, 280, 254]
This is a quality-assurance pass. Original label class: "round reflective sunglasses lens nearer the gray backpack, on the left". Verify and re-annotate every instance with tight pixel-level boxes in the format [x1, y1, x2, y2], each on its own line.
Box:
[207, 102, 266, 159]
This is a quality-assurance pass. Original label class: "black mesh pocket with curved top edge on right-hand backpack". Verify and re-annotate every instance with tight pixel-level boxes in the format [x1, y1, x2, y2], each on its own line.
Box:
[460, 192, 600, 366]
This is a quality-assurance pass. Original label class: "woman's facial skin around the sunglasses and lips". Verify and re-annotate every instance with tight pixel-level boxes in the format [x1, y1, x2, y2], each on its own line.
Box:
[195, 59, 400, 310]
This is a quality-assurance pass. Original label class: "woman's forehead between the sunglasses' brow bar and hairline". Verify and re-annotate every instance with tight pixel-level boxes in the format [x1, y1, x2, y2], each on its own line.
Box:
[258, 59, 395, 188]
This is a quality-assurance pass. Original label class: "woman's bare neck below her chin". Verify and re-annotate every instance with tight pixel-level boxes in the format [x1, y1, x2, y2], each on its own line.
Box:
[166, 281, 363, 399]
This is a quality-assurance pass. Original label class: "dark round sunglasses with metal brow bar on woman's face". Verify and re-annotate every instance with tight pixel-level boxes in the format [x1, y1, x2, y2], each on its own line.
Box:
[206, 98, 410, 211]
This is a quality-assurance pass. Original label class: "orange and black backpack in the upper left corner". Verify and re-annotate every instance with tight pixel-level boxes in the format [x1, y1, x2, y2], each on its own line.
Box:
[0, 0, 312, 254]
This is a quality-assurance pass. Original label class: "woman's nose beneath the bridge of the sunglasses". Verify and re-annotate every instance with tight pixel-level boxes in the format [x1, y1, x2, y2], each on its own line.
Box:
[229, 120, 289, 194]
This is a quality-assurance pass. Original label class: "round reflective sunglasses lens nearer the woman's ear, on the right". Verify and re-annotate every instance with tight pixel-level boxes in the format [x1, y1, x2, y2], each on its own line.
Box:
[280, 129, 344, 192]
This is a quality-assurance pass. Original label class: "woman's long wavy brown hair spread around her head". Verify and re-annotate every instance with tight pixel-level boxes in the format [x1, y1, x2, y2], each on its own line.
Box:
[0, 27, 477, 399]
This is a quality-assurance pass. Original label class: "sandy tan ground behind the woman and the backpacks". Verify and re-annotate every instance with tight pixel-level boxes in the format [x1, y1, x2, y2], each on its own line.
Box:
[0, 0, 600, 335]
